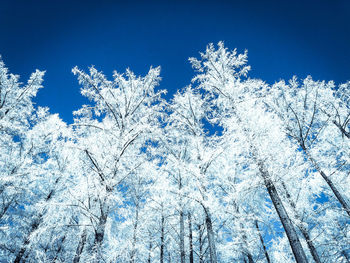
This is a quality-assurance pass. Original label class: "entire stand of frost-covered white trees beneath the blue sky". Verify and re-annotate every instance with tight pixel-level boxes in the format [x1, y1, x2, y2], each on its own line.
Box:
[0, 42, 350, 263]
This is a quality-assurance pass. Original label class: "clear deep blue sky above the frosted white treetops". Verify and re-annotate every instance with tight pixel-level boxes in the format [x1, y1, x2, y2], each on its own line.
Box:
[0, 0, 350, 122]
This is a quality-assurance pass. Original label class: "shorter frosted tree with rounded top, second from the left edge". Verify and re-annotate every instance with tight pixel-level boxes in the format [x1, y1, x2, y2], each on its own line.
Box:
[14, 109, 69, 262]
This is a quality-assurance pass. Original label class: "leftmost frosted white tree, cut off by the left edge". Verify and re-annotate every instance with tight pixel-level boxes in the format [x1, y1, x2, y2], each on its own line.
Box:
[0, 58, 44, 258]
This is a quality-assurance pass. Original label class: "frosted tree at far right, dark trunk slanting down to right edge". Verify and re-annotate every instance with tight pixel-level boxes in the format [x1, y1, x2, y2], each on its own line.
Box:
[274, 77, 350, 216]
